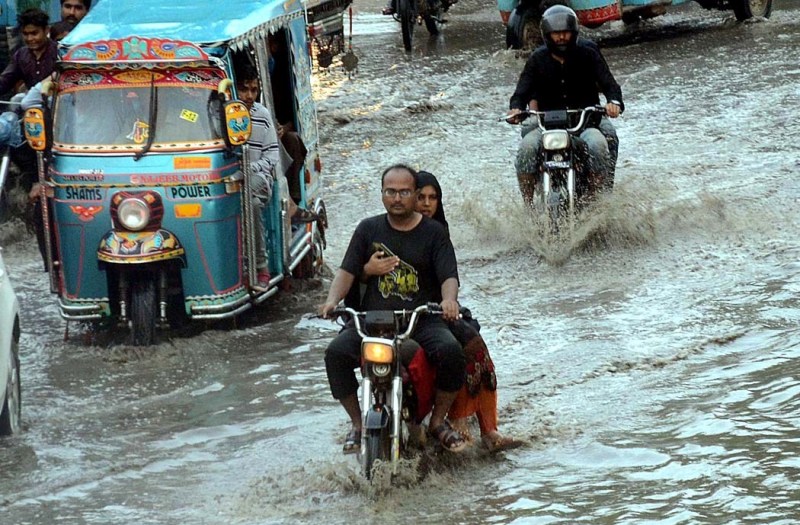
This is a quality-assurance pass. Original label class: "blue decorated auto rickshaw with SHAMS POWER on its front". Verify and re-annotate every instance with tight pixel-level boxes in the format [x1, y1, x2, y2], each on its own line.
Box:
[25, 0, 327, 345]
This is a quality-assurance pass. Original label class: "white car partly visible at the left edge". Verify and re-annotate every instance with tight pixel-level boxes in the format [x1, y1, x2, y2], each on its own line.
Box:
[0, 251, 22, 435]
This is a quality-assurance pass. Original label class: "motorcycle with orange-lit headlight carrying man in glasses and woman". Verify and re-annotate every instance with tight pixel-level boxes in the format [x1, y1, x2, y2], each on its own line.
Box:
[331, 303, 442, 479]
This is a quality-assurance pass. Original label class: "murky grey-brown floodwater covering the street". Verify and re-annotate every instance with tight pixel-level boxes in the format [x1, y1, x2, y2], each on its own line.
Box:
[0, 0, 800, 524]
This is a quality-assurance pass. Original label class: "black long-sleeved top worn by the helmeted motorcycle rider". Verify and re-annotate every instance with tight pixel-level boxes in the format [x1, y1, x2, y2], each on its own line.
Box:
[509, 38, 625, 111]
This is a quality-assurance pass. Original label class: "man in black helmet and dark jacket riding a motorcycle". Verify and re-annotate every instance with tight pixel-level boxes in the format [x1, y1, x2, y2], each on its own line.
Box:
[507, 5, 625, 205]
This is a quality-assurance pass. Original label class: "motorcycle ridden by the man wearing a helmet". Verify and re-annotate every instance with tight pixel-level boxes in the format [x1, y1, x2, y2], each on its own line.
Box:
[506, 106, 613, 233]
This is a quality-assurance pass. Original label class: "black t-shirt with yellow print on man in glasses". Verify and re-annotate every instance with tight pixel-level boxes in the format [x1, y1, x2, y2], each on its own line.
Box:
[341, 214, 458, 310]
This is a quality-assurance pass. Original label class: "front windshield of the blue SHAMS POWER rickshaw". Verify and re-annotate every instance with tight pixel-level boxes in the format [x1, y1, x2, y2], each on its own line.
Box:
[53, 70, 224, 150]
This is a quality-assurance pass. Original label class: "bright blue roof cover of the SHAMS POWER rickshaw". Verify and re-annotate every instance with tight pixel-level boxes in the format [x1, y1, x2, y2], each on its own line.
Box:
[61, 0, 303, 46]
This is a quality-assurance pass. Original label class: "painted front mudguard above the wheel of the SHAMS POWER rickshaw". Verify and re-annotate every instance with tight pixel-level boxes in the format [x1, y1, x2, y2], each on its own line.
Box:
[97, 229, 185, 264]
